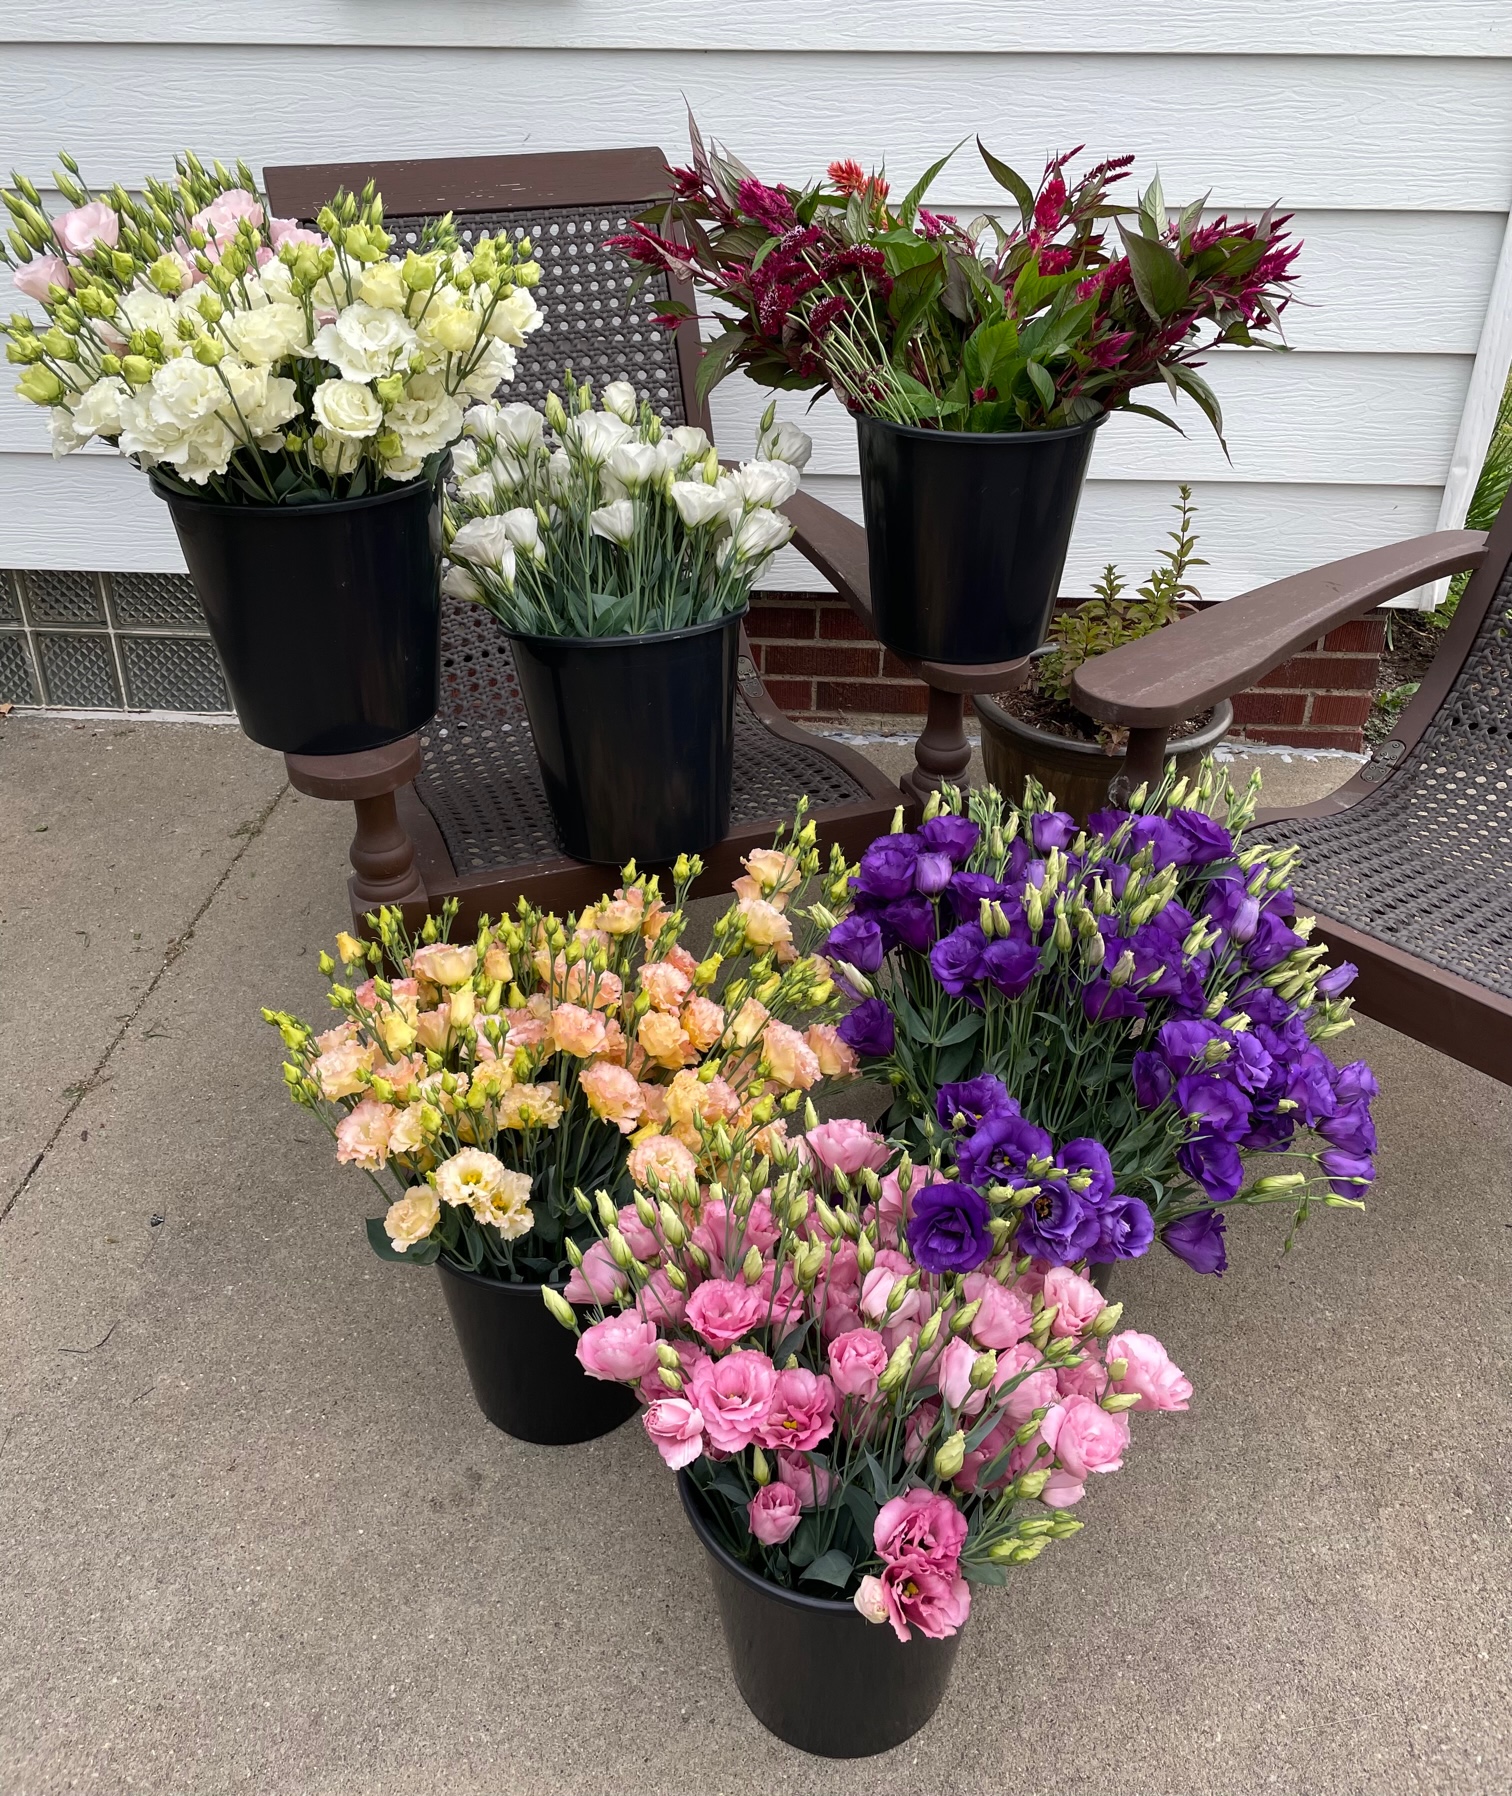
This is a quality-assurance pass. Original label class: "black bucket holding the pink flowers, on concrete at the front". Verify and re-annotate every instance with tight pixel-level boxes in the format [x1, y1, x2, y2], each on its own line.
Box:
[677, 1473, 964, 1758]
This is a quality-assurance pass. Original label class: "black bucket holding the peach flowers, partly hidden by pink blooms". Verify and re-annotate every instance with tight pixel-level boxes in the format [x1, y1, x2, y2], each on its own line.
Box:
[436, 1261, 637, 1448]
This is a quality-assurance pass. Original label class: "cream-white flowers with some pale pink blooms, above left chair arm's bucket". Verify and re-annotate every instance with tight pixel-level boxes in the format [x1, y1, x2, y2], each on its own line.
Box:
[0, 154, 541, 505]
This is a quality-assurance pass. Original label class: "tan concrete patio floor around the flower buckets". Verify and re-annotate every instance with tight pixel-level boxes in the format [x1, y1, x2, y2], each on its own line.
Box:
[0, 715, 1512, 1796]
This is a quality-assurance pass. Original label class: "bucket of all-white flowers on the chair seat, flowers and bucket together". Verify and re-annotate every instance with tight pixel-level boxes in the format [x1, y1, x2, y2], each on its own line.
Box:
[445, 372, 810, 864]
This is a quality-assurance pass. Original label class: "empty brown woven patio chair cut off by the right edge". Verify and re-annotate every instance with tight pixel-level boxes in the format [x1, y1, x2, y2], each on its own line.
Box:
[1072, 499, 1512, 1083]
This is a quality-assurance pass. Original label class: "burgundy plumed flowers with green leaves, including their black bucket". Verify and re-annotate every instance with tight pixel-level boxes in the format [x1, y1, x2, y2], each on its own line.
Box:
[611, 129, 1300, 665]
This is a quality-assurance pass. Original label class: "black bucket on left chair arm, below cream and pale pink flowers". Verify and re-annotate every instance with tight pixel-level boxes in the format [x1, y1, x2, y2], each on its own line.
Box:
[153, 480, 442, 754]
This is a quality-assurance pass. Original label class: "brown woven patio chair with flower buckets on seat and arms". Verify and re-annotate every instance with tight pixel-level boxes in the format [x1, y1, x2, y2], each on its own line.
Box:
[266, 149, 1011, 923]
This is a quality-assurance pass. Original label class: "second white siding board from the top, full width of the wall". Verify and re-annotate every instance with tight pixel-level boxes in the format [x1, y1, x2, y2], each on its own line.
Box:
[0, 47, 1512, 212]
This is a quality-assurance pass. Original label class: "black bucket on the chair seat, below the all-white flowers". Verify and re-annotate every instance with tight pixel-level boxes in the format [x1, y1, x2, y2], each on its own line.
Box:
[510, 611, 745, 867]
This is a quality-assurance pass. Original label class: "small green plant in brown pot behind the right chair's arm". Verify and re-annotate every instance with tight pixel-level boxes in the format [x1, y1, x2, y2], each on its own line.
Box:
[971, 487, 1234, 817]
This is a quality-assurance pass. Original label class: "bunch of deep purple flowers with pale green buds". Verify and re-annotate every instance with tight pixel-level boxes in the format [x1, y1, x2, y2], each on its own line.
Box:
[826, 767, 1379, 1272]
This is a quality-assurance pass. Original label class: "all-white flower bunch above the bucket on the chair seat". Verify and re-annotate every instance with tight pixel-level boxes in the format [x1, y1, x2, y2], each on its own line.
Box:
[445, 370, 812, 638]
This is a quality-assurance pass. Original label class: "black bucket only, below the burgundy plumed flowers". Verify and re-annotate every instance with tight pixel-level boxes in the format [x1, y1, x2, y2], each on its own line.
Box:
[857, 417, 1103, 665]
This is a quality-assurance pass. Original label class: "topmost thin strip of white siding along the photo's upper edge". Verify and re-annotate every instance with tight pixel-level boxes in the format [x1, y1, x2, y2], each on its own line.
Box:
[0, 0, 1512, 56]
